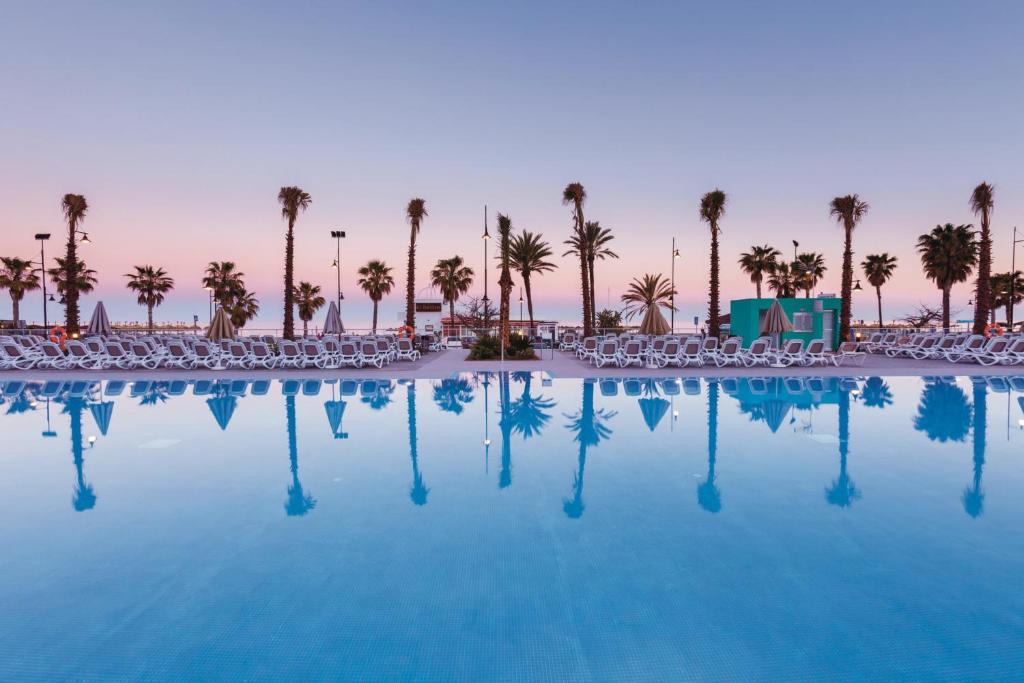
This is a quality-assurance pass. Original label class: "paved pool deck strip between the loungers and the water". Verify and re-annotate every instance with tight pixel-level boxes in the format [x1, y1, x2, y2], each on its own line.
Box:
[0, 349, 1024, 382]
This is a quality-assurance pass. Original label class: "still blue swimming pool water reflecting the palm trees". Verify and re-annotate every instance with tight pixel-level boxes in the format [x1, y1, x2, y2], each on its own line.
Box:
[0, 374, 1024, 681]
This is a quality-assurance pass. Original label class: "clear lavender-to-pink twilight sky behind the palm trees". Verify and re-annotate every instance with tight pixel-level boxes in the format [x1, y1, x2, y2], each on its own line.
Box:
[0, 1, 1024, 327]
